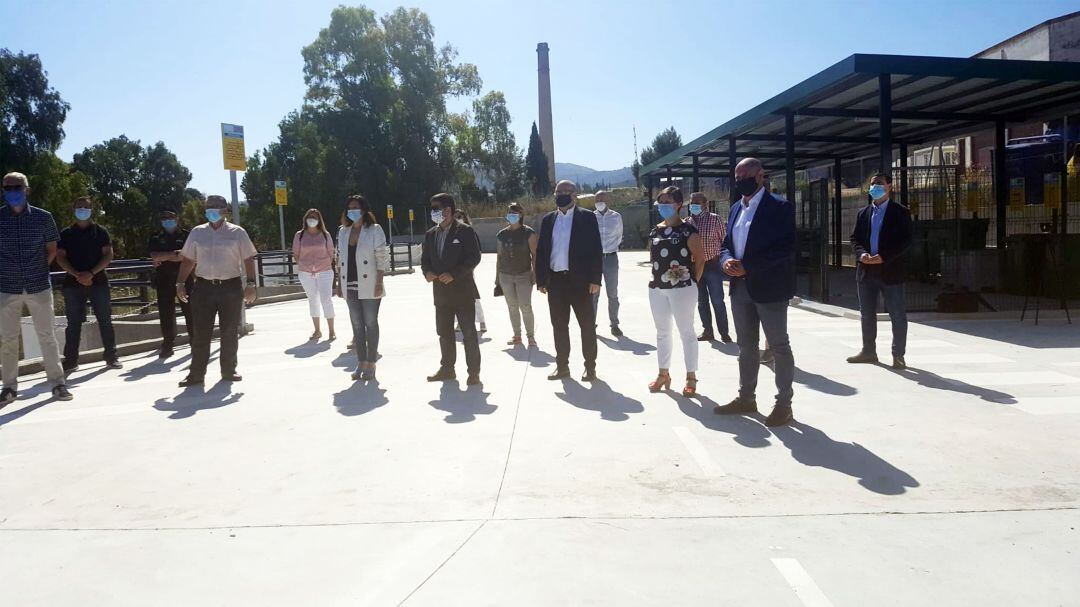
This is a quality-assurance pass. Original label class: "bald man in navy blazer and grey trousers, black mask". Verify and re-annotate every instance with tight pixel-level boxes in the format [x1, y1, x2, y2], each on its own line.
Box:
[714, 158, 795, 426]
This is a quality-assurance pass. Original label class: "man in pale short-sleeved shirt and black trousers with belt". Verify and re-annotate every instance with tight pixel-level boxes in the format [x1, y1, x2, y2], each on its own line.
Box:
[176, 195, 258, 388]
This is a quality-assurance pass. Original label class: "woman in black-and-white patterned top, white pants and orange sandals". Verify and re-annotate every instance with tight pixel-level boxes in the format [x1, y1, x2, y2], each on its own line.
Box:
[649, 186, 705, 396]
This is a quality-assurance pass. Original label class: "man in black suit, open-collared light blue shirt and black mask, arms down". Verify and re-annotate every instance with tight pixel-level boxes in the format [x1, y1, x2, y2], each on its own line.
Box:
[536, 180, 604, 381]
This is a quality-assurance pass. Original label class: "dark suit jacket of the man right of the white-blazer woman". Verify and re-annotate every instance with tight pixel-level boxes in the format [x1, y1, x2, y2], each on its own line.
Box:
[420, 221, 480, 306]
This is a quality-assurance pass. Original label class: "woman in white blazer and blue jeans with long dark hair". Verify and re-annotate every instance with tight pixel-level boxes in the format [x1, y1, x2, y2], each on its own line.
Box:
[337, 194, 390, 381]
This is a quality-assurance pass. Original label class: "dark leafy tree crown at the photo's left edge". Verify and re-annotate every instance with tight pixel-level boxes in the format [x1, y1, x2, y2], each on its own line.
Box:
[0, 49, 71, 173]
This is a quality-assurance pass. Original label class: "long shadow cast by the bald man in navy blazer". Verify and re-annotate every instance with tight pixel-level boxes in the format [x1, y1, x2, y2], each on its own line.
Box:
[772, 421, 919, 496]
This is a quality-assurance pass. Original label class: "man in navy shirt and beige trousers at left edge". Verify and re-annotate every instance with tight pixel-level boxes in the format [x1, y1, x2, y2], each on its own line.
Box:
[0, 173, 71, 407]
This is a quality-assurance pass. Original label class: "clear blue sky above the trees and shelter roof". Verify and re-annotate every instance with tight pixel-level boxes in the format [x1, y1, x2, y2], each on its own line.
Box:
[8, 0, 1080, 193]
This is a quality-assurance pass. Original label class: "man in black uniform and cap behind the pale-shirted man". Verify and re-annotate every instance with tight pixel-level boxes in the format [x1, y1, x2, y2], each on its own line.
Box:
[149, 210, 194, 359]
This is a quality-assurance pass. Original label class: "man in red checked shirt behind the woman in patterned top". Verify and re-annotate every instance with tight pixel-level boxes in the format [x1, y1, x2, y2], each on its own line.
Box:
[687, 192, 731, 343]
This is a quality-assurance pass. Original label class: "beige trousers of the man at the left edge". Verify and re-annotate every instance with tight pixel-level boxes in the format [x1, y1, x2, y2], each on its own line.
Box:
[0, 288, 64, 389]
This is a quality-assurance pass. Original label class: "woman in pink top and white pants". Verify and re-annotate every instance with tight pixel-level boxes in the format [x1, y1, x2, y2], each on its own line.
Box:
[293, 208, 337, 341]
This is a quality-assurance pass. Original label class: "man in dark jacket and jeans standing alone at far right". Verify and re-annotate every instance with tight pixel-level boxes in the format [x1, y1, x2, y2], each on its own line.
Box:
[848, 173, 912, 369]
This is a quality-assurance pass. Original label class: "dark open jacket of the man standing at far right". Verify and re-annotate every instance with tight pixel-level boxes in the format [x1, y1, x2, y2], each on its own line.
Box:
[851, 201, 912, 284]
